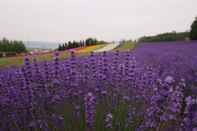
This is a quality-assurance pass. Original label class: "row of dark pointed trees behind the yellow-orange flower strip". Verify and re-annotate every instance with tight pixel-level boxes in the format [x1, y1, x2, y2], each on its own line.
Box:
[57, 38, 106, 51]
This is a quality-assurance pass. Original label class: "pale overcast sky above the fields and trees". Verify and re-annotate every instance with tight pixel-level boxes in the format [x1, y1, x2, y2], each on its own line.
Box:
[0, 0, 197, 42]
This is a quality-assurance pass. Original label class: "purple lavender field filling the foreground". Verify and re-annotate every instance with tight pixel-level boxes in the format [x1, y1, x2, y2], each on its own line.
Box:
[0, 41, 197, 131]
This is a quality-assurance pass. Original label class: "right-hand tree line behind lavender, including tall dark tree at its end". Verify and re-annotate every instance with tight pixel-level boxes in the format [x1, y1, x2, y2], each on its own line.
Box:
[138, 18, 197, 42]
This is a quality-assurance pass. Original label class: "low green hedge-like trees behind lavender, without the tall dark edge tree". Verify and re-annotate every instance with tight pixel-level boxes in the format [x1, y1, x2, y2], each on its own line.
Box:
[139, 31, 190, 42]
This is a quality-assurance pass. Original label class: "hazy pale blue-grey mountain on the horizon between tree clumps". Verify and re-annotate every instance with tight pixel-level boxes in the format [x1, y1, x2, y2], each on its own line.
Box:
[24, 41, 60, 49]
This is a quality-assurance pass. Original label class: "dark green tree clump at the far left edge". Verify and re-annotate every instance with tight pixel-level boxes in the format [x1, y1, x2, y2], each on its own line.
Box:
[0, 38, 27, 57]
